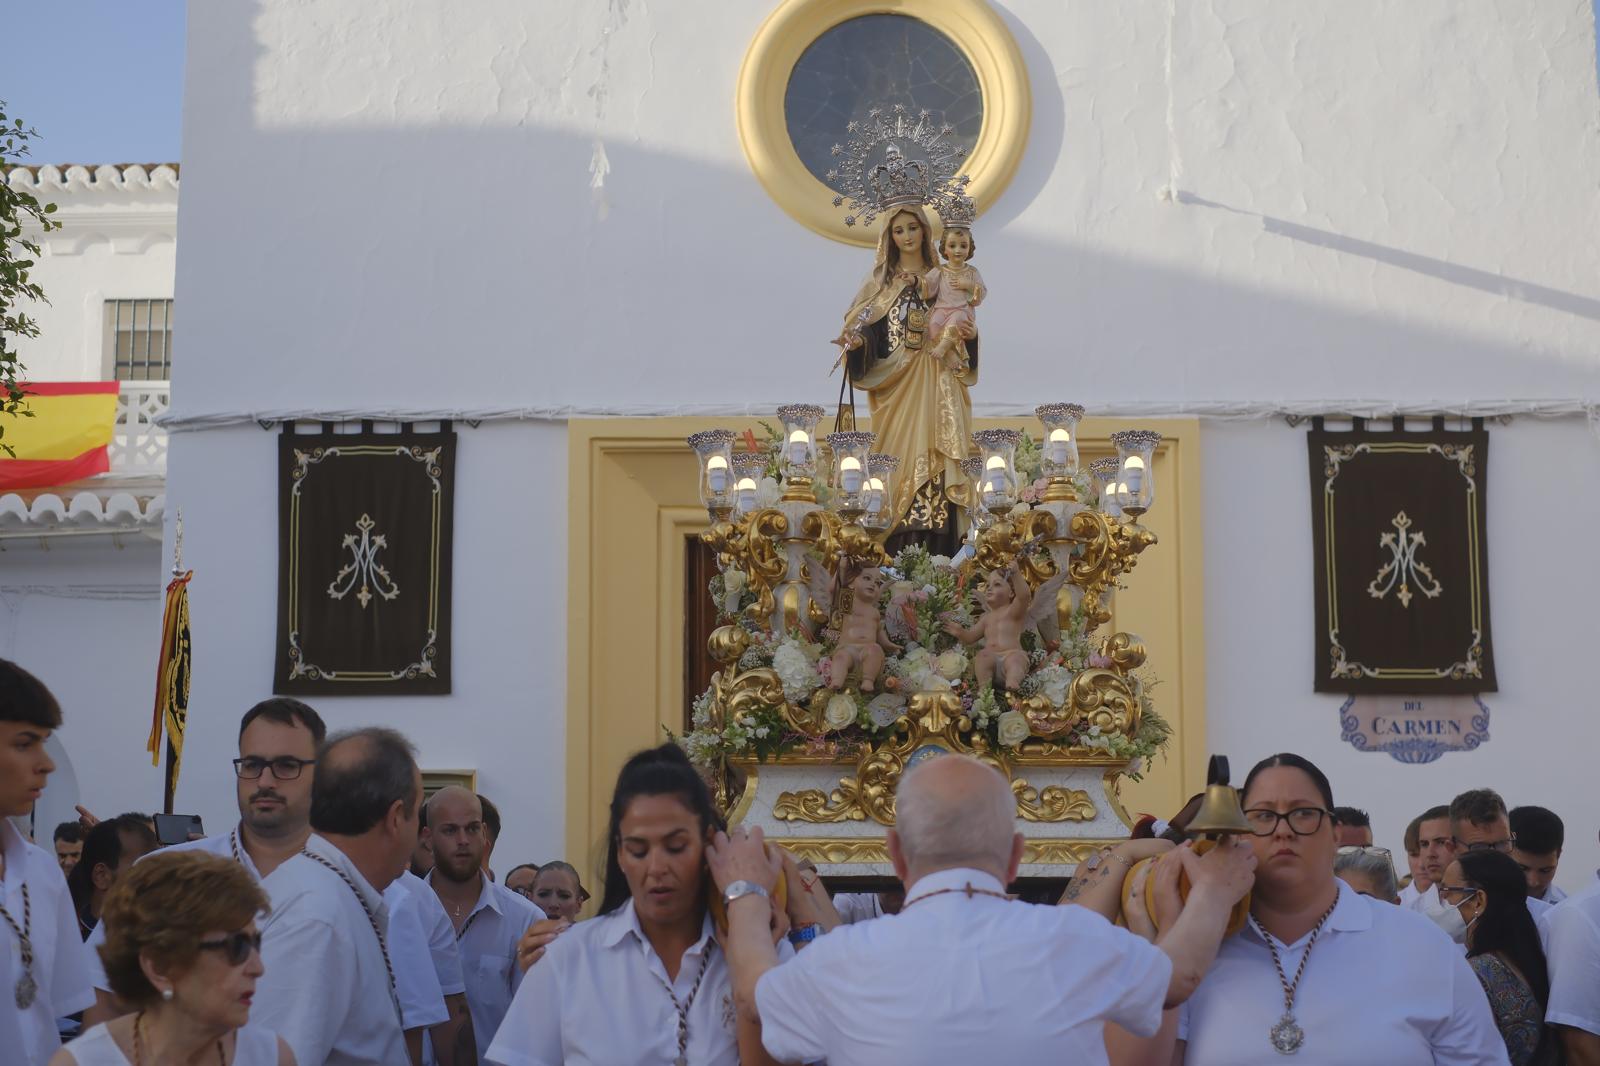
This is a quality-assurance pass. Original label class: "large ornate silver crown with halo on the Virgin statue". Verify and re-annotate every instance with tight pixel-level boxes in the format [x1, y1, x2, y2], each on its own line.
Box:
[827, 104, 970, 226]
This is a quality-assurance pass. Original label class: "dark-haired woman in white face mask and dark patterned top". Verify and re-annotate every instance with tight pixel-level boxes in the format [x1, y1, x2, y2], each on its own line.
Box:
[1438, 850, 1560, 1066]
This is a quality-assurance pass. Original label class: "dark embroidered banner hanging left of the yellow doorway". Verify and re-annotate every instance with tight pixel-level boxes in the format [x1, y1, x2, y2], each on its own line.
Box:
[272, 423, 456, 696]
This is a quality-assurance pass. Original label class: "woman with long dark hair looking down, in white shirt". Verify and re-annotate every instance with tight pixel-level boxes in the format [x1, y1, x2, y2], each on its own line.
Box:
[488, 744, 787, 1066]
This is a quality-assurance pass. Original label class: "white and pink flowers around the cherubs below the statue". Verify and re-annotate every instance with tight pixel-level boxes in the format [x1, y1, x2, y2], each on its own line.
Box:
[682, 534, 1171, 779]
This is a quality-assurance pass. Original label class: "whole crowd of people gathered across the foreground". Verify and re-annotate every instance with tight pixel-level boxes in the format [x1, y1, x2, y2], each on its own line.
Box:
[0, 661, 1600, 1066]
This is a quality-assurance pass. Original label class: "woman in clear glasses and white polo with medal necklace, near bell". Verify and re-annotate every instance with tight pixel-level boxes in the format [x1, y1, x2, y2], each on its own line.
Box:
[1171, 754, 1506, 1066]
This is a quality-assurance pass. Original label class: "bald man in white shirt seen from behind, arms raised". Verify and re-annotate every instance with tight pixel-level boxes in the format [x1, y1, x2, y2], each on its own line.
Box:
[707, 755, 1254, 1066]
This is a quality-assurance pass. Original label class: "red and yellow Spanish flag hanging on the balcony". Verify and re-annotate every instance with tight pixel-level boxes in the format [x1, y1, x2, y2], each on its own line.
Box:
[0, 381, 118, 493]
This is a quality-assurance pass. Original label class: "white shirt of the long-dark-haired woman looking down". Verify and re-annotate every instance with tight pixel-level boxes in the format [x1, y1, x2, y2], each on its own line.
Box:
[486, 900, 794, 1066]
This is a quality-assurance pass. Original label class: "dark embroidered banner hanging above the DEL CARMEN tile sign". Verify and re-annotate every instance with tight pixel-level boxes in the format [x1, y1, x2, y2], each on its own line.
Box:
[1309, 419, 1496, 696]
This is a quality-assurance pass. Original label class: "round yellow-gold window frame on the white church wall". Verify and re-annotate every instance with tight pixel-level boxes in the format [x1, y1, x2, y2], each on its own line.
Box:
[736, 0, 1034, 246]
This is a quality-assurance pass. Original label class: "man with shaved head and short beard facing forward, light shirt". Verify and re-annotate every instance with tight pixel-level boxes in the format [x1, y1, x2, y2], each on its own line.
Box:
[422, 784, 544, 1055]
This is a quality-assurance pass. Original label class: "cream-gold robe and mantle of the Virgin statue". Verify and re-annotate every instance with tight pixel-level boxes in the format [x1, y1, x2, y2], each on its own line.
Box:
[845, 201, 978, 528]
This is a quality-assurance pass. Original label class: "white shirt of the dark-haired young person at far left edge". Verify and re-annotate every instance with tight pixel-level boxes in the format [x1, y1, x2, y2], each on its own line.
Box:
[0, 818, 94, 1066]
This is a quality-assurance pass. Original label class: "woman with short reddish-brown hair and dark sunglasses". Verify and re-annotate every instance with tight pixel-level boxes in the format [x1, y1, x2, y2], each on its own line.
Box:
[50, 852, 294, 1066]
